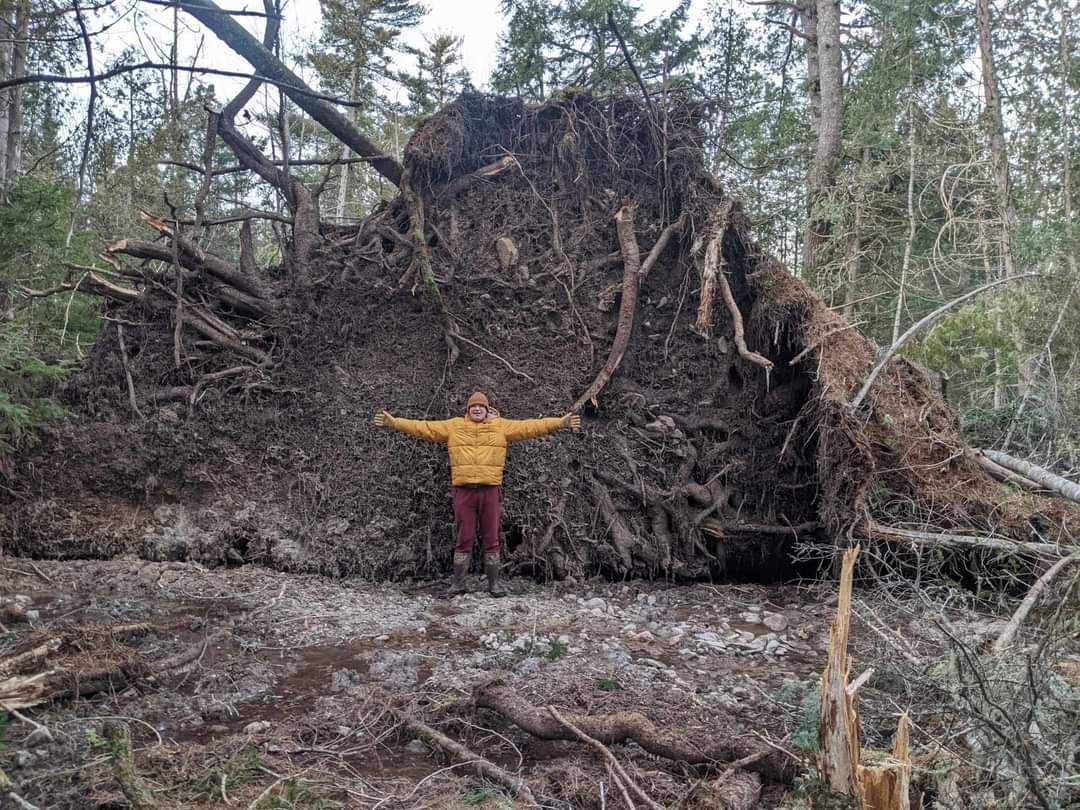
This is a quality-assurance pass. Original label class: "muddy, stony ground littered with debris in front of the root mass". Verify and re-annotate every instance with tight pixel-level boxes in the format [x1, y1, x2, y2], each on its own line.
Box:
[0, 557, 1049, 809]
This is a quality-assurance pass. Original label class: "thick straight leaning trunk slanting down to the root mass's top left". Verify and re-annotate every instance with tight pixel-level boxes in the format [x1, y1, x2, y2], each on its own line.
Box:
[179, 0, 402, 186]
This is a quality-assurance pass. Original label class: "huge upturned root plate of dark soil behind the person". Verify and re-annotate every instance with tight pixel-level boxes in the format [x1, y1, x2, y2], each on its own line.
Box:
[2, 94, 1066, 578]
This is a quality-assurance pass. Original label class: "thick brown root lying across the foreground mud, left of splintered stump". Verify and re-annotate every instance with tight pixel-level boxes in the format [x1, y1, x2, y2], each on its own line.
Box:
[473, 685, 795, 783]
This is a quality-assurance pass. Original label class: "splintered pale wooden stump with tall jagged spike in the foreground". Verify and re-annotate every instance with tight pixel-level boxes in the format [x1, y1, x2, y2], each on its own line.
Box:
[818, 545, 912, 810]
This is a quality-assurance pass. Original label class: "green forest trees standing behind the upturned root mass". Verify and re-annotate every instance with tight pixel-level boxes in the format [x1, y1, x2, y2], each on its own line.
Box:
[0, 0, 1080, 474]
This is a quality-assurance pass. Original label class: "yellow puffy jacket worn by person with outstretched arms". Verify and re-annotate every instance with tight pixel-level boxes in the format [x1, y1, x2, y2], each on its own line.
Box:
[389, 416, 563, 487]
